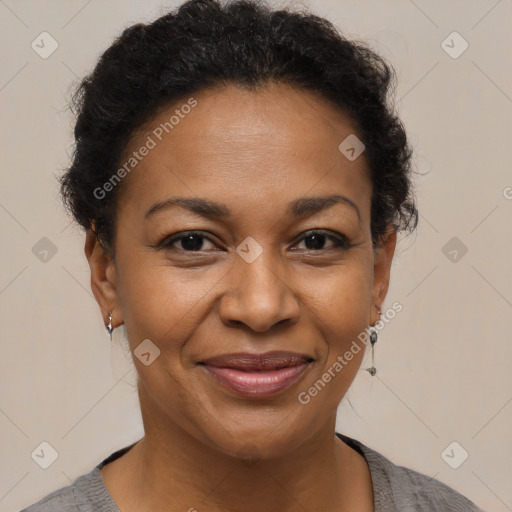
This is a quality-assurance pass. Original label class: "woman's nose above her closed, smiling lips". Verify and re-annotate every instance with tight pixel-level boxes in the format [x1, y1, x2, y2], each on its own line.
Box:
[219, 251, 300, 332]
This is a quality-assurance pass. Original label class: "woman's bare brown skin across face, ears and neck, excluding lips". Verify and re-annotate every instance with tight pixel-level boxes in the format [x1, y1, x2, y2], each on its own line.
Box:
[85, 84, 396, 512]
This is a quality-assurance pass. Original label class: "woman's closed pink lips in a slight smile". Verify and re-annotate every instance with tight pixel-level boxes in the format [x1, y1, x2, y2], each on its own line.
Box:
[201, 352, 312, 398]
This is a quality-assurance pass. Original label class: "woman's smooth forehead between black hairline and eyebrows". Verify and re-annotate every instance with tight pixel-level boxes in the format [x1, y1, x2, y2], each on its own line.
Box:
[118, 84, 371, 221]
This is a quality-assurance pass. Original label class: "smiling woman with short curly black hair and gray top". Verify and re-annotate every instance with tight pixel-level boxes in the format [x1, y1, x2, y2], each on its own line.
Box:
[26, 0, 479, 512]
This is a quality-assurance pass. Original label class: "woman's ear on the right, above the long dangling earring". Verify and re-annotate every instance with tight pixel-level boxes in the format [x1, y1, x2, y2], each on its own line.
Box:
[370, 225, 396, 325]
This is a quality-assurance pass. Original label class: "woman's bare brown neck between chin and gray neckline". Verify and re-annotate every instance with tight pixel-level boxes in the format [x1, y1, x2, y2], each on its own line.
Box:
[102, 388, 373, 512]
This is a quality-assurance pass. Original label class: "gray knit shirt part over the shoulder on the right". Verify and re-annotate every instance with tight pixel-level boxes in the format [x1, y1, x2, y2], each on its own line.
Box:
[337, 434, 484, 512]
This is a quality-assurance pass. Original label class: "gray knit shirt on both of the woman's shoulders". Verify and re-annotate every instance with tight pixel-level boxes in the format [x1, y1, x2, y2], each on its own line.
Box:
[21, 433, 483, 512]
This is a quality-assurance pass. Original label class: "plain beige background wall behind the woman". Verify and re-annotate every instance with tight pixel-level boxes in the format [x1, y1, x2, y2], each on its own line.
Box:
[0, 0, 512, 512]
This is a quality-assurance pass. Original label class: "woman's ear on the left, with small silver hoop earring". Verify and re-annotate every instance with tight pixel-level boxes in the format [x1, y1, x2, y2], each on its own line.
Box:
[84, 228, 123, 327]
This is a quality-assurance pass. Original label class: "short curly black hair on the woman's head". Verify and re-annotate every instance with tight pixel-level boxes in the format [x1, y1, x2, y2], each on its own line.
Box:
[59, 0, 418, 255]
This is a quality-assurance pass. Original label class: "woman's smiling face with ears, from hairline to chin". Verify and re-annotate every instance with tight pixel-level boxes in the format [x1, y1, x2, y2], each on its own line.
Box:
[86, 85, 396, 457]
